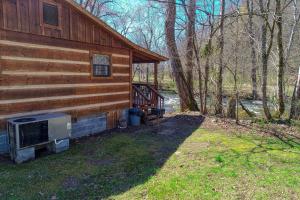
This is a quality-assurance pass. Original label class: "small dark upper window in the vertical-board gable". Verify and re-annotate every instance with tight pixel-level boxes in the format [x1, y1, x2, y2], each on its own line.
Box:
[43, 2, 59, 26]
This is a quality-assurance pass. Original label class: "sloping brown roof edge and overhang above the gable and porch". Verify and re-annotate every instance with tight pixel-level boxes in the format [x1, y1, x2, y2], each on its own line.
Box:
[65, 0, 169, 63]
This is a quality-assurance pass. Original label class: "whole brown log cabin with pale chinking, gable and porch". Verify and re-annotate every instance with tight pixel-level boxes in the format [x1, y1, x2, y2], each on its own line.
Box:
[0, 0, 167, 152]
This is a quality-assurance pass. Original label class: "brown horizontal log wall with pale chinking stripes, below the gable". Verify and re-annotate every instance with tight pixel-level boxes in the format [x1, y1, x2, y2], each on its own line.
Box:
[0, 35, 131, 129]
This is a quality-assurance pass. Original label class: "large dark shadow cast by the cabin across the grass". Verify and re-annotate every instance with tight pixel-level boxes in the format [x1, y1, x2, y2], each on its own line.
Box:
[0, 115, 204, 199]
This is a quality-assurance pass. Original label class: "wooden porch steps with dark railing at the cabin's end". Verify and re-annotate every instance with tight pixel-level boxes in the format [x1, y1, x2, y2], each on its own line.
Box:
[132, 83, 165, 122]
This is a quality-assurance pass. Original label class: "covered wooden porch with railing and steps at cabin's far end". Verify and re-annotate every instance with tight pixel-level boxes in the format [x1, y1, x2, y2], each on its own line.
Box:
[131, 49, 168, 120]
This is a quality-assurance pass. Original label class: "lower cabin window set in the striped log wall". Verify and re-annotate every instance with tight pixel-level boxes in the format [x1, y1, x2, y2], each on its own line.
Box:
[92, 54, 111, 77]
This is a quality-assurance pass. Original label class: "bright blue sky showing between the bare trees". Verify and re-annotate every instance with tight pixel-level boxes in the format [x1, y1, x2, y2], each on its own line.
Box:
[76, 0, 223, 51]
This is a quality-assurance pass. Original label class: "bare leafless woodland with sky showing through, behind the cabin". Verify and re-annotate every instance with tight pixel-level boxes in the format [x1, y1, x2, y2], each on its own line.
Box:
[77, 0, 300, 120]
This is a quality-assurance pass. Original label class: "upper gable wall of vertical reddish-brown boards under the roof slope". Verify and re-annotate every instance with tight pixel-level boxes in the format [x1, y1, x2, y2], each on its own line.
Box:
[0, 0, 127, 48]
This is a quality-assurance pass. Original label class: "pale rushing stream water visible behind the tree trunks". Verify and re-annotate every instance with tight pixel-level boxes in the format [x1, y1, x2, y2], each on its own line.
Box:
[161, 91, 284, 116]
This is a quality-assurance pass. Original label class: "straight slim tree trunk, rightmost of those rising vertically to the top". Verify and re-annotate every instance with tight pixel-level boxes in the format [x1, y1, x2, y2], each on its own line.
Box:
[276, 0, 285, 116]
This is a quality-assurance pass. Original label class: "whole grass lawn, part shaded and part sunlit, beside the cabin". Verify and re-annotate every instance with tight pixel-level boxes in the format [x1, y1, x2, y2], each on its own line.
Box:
[0, 116, 300, 200]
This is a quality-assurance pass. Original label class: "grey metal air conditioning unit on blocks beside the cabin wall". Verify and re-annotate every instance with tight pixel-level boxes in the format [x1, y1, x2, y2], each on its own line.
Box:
[7, 113, 71, 163]
